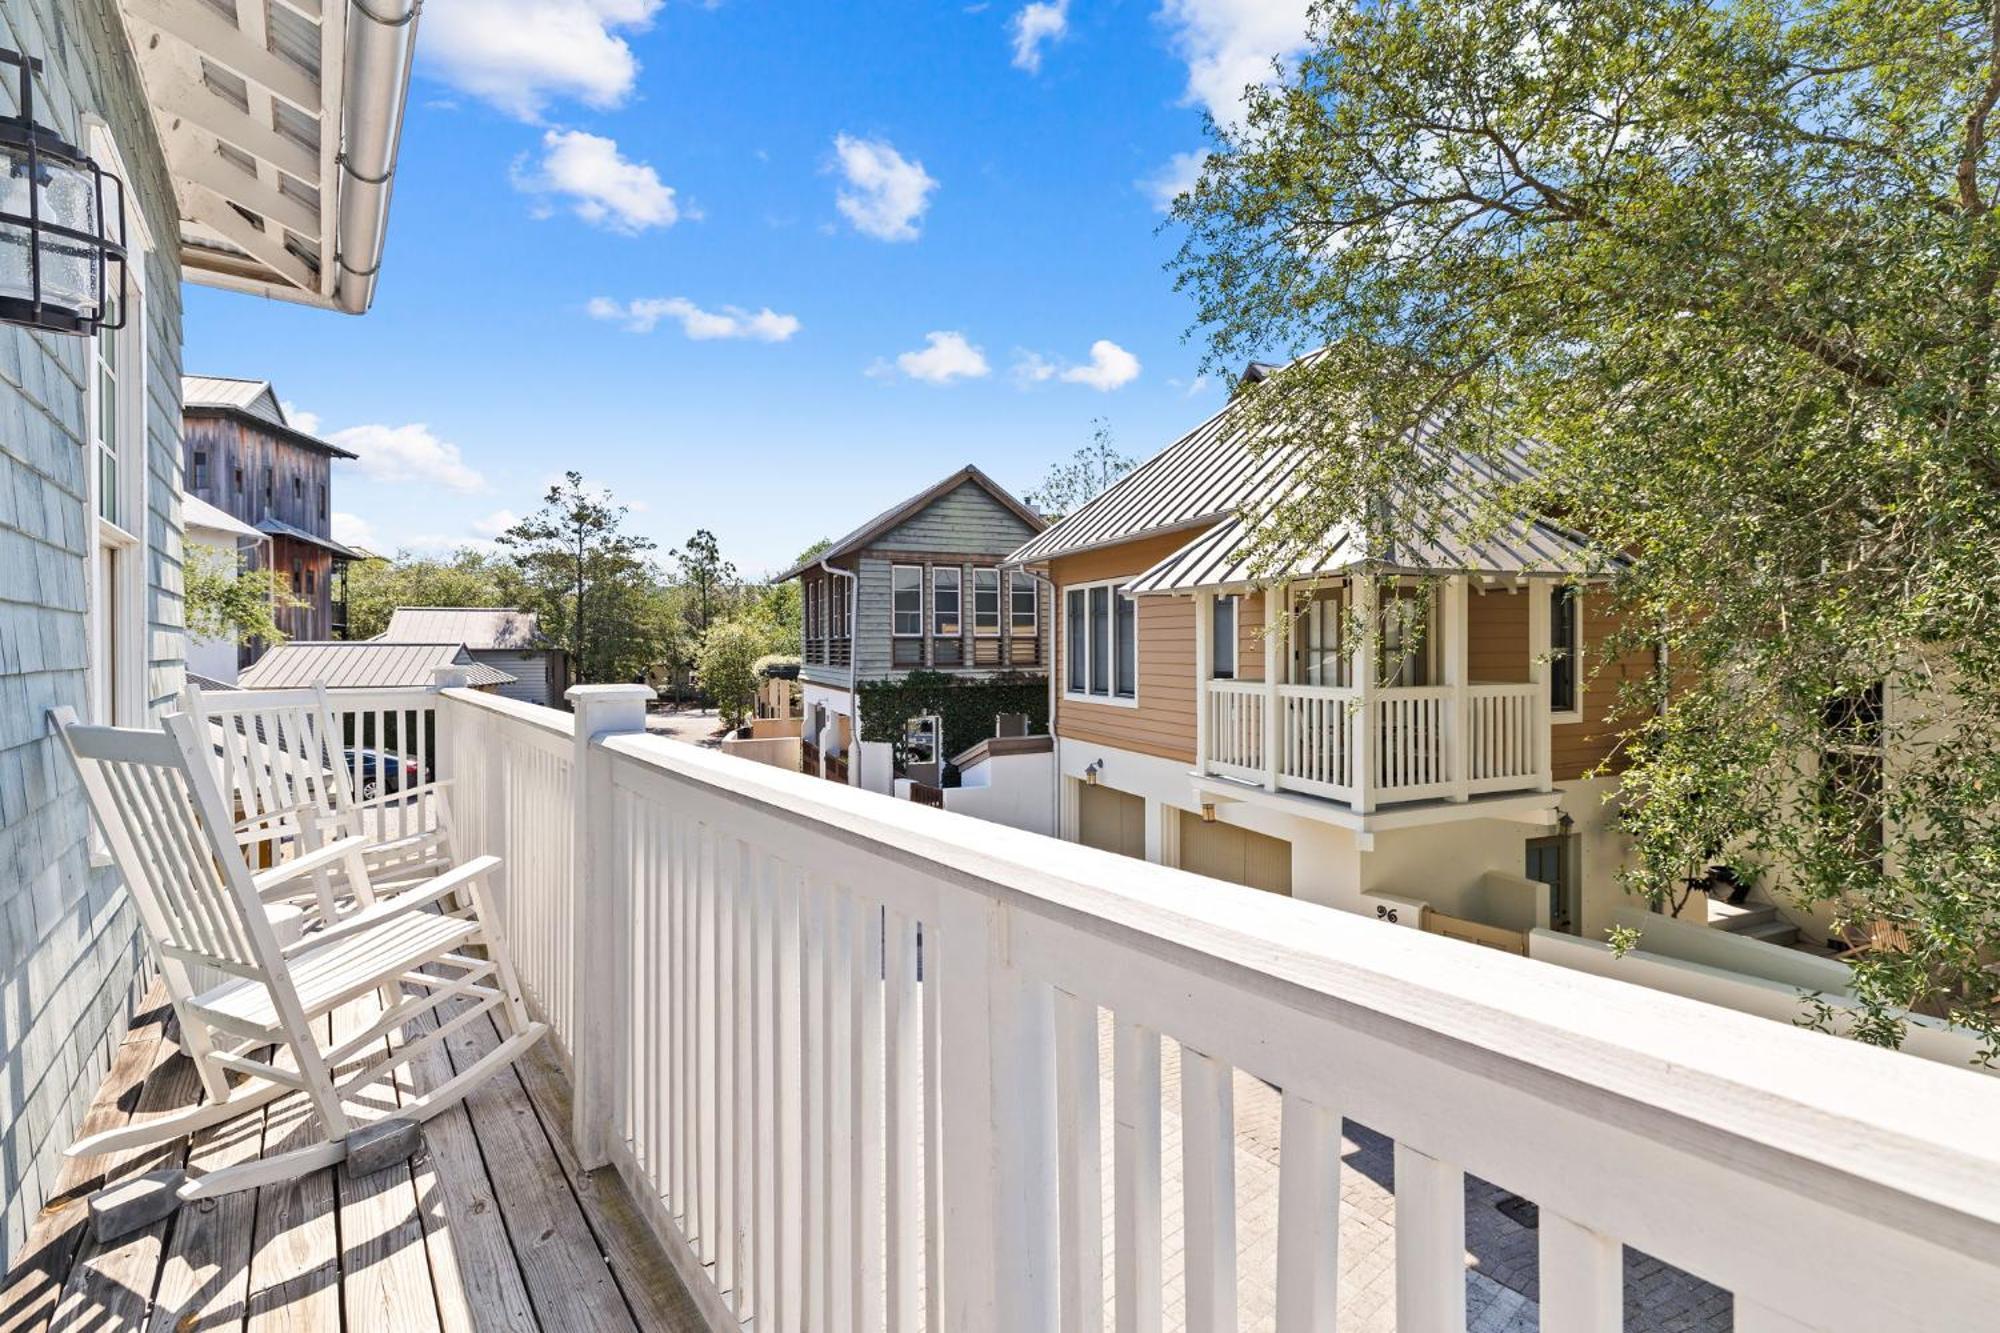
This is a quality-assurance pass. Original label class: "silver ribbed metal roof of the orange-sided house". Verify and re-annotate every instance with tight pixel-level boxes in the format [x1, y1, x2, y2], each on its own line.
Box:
[1006, 364, 1602, 592]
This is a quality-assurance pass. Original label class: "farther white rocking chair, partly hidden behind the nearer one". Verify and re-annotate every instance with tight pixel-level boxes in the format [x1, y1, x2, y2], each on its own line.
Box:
[184, 685, 458, 908]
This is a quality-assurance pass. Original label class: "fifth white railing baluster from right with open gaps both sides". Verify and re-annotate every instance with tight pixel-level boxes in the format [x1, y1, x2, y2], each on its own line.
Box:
[1112, 1019, 1160, 1333]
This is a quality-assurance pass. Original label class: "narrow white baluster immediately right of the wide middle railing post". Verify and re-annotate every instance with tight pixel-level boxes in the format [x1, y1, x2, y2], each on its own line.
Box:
[1056, 991, 1104, 1333]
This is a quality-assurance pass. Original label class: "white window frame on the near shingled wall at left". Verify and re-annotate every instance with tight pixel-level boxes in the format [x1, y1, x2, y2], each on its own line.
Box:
[84, 116, 152, 727]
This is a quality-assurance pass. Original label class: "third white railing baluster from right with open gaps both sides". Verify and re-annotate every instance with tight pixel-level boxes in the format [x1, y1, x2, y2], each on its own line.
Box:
[1278, 1093, 1340, 1333]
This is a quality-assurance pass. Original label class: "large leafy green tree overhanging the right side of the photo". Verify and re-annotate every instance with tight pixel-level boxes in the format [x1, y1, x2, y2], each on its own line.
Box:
[1174, 0, 2000, 1041]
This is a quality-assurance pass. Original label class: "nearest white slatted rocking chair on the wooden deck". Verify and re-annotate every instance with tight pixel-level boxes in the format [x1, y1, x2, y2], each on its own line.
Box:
[50, 709, 548, 1201]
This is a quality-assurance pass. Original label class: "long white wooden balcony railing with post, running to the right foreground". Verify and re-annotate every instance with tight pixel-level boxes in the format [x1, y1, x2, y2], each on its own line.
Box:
[440, 687, 2000, 1333]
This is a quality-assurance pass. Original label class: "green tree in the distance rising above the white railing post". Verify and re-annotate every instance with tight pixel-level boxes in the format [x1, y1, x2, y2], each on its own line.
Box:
[500, 472, 658, 683]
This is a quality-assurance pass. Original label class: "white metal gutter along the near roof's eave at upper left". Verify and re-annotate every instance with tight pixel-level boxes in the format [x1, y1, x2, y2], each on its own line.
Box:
[334, 0, 424, 314]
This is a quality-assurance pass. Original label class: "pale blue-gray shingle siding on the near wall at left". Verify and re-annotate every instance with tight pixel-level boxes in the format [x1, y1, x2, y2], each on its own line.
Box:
[0, 0, 184, 1253]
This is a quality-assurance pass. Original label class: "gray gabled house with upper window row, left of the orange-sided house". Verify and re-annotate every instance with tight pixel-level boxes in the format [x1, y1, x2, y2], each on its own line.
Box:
[778, 464, 1050, 772]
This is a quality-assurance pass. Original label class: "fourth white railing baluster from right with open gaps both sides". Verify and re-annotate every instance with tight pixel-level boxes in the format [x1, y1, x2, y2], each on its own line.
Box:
[1180, 1047, 1236, 1333]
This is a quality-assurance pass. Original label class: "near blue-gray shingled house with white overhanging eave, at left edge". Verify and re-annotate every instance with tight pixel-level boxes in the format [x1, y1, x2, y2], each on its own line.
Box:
[0, 0, 414, 1256]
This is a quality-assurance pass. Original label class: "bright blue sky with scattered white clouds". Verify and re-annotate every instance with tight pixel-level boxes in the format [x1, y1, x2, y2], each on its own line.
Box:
[186, 0, 1304, 574]
